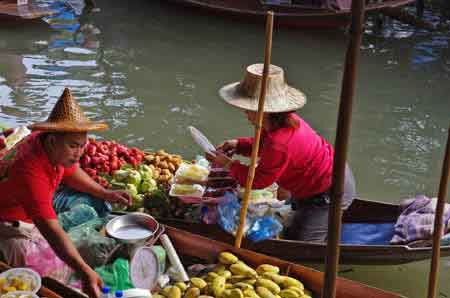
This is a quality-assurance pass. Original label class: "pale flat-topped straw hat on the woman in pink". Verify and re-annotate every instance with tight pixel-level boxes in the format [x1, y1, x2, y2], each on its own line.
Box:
[219, 64, 306, 113]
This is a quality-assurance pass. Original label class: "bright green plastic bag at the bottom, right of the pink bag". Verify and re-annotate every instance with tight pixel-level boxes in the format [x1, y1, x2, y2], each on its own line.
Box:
[95, 258, 134, 292]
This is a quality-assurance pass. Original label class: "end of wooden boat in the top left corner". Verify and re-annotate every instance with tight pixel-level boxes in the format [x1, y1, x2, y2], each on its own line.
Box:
[0, 0, 56, 23]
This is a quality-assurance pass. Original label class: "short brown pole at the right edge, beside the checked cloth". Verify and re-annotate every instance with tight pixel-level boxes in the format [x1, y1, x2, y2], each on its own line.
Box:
[428, 127, 450, 298]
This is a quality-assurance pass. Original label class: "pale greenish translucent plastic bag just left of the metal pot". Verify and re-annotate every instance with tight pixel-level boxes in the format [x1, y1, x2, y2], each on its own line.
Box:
[68, 218, 117, 267]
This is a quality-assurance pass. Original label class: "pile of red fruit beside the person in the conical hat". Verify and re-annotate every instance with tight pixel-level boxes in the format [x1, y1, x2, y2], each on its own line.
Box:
[80, 138, 144, 187]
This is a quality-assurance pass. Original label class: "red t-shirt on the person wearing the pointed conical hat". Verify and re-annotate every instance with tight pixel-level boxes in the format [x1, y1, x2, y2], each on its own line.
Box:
[0, 132, 78, 223]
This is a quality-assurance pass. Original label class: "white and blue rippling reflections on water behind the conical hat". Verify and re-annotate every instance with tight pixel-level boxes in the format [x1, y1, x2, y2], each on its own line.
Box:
[0, 1, 140, 136]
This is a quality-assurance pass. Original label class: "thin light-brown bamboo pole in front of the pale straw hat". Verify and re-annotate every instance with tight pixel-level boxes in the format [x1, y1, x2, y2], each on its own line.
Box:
[234, 11, 273, 248]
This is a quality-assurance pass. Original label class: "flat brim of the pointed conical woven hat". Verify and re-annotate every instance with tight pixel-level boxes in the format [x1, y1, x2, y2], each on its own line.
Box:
[28, 122, 108, 132]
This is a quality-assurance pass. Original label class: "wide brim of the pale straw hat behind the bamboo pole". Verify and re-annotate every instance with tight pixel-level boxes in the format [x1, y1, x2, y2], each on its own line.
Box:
[219, 82, 306, 113]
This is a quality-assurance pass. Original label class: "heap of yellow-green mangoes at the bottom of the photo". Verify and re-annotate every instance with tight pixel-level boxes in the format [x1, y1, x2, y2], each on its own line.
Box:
[153, 252, 312, 298]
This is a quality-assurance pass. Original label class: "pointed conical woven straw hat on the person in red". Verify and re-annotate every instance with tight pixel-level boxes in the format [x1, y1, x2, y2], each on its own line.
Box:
[28, 88, 108, 132]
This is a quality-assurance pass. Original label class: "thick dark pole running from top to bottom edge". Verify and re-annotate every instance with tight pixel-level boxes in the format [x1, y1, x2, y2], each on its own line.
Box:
[322, 0, 365, 298]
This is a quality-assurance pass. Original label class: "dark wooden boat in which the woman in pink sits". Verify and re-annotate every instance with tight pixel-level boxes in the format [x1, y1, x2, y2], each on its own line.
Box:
[158, 199, 450, 265]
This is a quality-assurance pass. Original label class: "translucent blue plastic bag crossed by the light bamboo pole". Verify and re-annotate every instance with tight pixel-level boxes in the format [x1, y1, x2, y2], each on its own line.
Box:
[217, 193, 283, 242]
